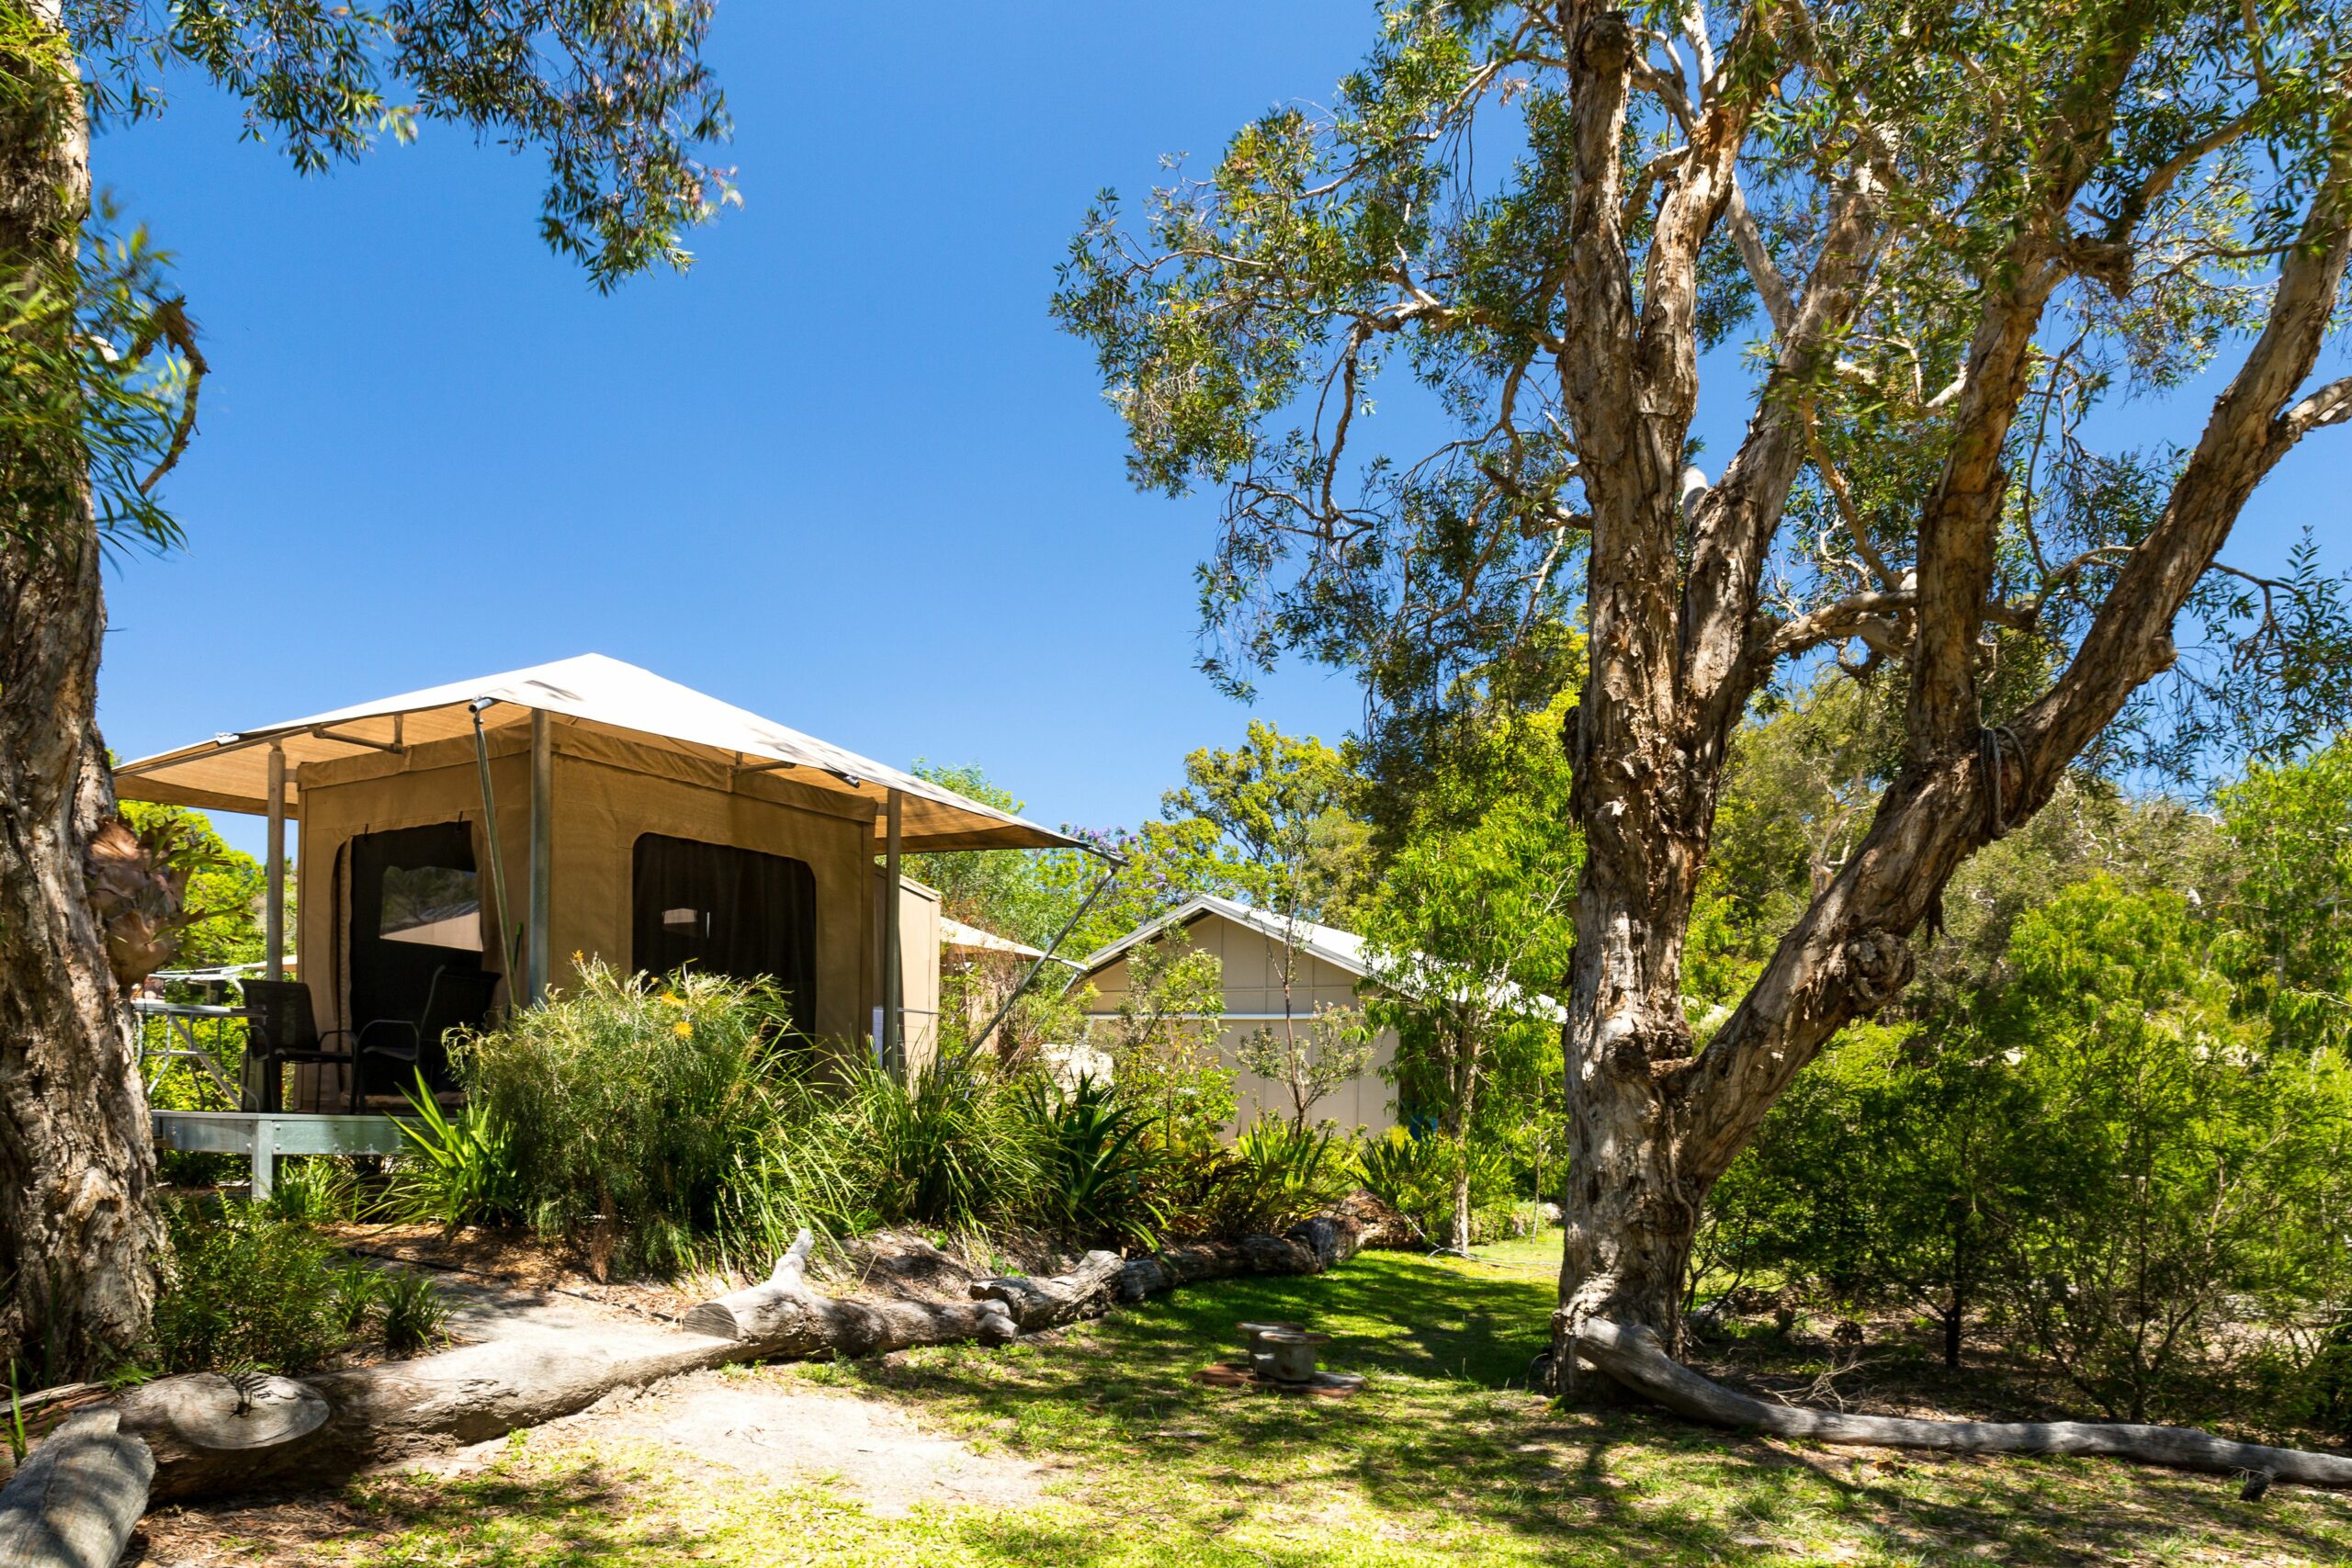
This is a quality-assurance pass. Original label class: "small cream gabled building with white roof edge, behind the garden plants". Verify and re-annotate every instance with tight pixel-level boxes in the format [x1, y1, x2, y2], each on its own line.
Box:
[1080, 894, 1397, 1134]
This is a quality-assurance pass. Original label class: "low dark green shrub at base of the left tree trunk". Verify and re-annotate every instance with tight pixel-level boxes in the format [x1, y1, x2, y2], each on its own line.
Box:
[155, 1199, 350, 1373]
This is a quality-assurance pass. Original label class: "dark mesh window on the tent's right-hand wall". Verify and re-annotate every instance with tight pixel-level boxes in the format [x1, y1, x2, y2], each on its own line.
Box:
[630, 832, 816, 1032]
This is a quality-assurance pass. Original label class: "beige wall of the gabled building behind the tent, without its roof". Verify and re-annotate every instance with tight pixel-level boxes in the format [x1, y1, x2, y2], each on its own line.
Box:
[1089, 915, 1397, 1134]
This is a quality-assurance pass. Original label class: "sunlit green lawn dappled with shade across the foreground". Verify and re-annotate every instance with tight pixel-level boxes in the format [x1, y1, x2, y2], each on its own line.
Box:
[214, 1241, 2352, 1568]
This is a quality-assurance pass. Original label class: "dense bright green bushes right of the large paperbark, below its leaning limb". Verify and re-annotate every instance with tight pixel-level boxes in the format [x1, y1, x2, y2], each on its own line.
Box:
[1693, 874, 2352, 1420]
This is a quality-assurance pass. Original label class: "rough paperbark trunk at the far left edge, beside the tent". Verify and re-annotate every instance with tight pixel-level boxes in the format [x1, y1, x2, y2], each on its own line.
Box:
[0, 0, 163, 1382]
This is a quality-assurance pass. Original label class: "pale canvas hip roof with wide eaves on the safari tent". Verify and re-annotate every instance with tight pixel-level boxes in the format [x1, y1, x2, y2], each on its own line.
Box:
[115, 653, 1080, 849]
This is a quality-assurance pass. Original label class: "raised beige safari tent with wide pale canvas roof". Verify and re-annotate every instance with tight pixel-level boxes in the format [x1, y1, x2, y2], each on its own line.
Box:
[115, 653, 1075, 1110]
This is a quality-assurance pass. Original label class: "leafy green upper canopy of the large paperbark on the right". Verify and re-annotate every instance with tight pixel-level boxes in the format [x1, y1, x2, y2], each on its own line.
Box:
[1054, 0, 2352, 771]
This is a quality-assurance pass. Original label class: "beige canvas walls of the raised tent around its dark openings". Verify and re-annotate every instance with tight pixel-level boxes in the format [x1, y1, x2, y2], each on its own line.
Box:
[297, 727, 938, 1072]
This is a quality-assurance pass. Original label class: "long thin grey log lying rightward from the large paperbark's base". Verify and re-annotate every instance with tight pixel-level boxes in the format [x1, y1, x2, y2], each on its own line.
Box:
[1574, 1319, 2352, 1488]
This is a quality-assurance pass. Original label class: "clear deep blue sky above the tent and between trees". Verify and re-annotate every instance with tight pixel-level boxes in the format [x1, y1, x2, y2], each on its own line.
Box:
[94, 0, 2347, 860]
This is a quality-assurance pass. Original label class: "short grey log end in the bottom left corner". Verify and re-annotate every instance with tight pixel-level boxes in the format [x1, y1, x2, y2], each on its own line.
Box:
[0, 1411, 155, 1568]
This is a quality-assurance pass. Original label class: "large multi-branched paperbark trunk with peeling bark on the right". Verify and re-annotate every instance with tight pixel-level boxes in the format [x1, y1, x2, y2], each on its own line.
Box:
[1553, 5, 2352, 1392]
